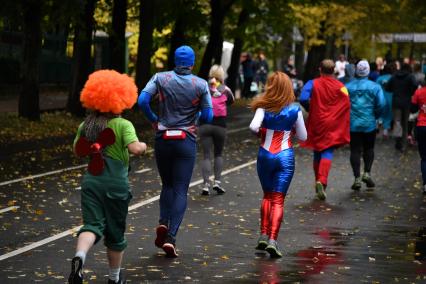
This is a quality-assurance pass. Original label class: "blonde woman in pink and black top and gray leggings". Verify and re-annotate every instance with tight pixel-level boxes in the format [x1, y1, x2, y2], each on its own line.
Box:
[199, 65, 234, 195]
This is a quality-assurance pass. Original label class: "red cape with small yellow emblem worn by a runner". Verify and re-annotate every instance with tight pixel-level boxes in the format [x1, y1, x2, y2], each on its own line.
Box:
[302, 76, 350, 151]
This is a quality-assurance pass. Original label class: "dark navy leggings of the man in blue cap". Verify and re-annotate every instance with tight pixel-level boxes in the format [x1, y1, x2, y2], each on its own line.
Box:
[155, 135, 197, 237]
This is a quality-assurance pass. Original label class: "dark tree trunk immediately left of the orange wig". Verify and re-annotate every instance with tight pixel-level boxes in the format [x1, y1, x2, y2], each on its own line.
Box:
[67, 0, 96, 116]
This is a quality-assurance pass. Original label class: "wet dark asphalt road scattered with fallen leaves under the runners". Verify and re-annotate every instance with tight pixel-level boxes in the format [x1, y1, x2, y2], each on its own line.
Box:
[0, 107, 426, 283]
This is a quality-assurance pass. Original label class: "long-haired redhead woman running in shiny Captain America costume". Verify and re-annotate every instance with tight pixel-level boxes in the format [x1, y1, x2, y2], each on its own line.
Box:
[250, 72, 306, 257]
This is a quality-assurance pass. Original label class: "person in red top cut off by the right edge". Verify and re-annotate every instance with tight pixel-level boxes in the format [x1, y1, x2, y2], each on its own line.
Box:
[411, 81, 426, 194]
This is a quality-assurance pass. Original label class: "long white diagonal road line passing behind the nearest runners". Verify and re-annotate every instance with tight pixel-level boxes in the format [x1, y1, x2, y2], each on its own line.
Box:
[0, 160, 256, 261]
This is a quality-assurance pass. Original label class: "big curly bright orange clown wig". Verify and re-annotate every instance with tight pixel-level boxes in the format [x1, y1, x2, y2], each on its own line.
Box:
[80, 70, 138, 114]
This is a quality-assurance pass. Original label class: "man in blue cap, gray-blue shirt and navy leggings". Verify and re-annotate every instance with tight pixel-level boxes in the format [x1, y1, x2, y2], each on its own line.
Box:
[138, 45, 213, 257]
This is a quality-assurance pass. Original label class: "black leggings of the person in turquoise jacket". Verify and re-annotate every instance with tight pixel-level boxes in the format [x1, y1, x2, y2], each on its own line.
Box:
[351, 130, 376, 177]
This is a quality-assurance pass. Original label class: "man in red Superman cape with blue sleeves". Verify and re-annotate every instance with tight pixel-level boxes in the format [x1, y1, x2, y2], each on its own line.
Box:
[300, 59, 350, 200]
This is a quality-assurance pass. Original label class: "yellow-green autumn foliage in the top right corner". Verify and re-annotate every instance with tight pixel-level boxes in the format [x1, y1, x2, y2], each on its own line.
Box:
[290, 0, 426, 58]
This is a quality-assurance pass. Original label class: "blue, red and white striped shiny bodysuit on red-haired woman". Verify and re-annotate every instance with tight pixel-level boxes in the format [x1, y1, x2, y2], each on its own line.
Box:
[250, 104, 307, 240]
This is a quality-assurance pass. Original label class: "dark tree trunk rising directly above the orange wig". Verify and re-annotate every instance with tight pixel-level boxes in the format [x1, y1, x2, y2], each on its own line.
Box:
[109, 0, 127, 73]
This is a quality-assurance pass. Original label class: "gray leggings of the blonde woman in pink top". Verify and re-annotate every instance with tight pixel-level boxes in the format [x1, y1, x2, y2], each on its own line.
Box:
[198, 124, 226, 183]
